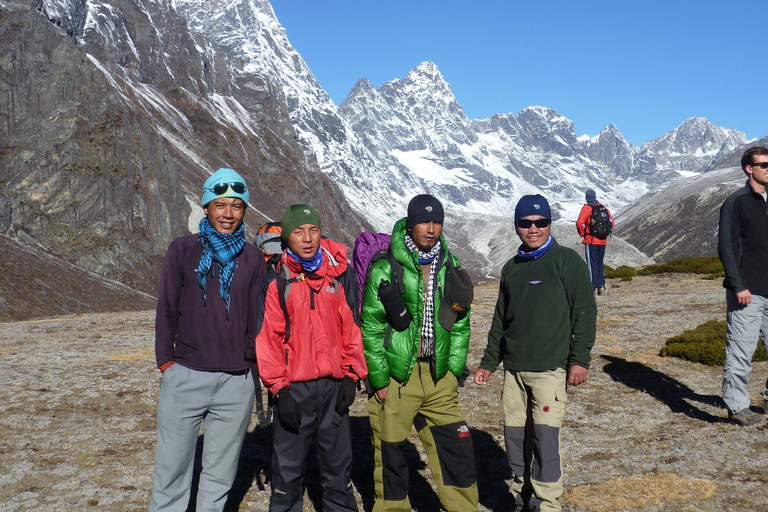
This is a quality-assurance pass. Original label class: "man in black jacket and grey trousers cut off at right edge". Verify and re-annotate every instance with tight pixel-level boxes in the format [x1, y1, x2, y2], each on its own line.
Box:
[717, 147, 768, 426]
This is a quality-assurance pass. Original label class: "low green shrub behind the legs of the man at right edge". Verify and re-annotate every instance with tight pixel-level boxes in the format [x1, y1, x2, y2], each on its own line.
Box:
[660, 320, 768, 366]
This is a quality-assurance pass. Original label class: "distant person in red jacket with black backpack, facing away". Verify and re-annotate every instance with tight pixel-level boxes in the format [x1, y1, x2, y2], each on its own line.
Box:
[576, 189, 613, 295]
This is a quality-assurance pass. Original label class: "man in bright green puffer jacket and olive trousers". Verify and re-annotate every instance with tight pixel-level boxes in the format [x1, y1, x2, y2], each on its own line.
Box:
[361, 195, 478, 512]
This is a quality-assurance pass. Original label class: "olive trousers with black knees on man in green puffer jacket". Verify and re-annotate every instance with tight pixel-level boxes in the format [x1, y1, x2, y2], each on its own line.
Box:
[368, 362, 478, 512]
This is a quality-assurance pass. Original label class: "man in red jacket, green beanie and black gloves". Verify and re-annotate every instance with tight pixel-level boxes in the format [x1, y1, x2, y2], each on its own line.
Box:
[256, 204, 368, 512]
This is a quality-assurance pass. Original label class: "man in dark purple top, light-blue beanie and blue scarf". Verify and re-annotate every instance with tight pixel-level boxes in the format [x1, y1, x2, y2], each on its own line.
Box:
[150, 169, 266, 512]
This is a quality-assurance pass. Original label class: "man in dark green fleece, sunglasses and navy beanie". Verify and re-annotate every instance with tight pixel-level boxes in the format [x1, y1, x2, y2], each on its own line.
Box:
[475, 195, 597, 511]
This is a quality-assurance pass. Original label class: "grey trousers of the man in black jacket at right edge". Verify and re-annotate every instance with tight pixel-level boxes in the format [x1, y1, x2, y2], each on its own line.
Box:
[723, 290, 768, 412]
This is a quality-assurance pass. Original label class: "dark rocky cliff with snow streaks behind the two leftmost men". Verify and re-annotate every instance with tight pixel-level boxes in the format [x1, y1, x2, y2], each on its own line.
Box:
[0, 0, 365, 308]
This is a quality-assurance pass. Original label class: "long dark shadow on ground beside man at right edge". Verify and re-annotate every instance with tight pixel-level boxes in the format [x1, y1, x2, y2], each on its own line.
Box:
[601, 355, 724, 423]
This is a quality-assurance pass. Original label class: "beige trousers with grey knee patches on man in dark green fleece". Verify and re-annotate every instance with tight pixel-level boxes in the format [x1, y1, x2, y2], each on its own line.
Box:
[502, 368, 568, 512]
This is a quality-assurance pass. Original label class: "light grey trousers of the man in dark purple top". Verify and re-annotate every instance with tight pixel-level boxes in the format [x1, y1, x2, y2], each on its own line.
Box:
[149, 363, 254, 512]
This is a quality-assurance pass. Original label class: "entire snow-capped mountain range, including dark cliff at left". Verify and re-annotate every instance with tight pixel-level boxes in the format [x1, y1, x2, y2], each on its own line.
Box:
[0, 0, 760, 306]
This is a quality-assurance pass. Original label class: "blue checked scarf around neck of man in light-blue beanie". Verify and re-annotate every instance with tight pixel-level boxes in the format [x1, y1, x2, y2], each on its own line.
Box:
[197, 217, 245, 318]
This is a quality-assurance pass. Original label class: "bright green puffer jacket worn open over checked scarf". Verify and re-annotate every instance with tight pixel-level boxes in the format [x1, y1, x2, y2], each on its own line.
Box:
[361, 218, 470, 389]
